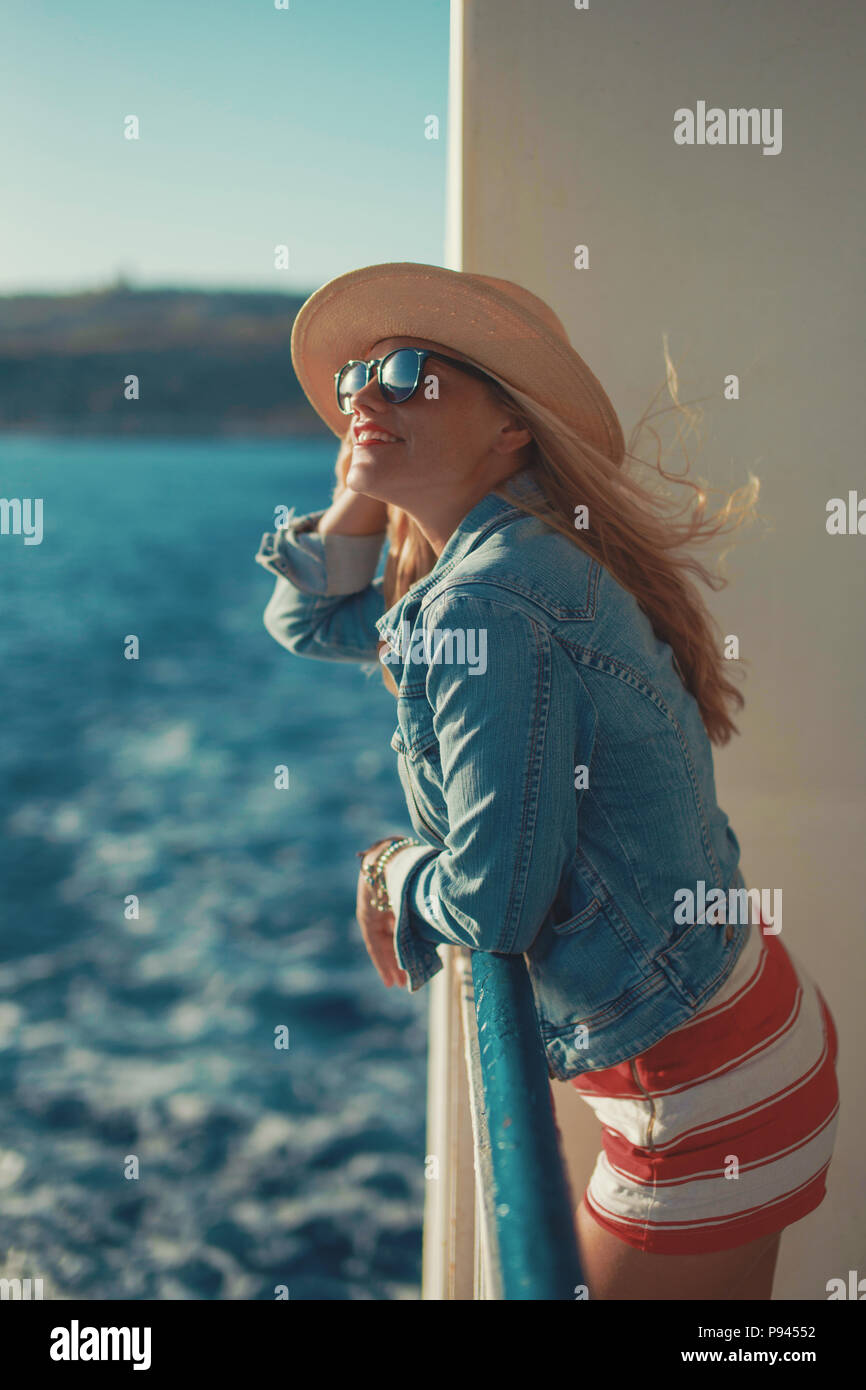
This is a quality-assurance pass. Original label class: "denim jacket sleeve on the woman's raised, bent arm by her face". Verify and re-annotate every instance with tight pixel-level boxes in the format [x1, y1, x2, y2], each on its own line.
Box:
[256, 509, 385, 662]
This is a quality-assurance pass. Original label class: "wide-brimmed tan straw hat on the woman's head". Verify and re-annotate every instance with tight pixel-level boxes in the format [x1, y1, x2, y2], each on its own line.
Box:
[292, 261, 626, 466]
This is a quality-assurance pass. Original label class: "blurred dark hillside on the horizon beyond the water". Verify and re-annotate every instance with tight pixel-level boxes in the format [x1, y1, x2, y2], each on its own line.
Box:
[0, 284, 327, 435]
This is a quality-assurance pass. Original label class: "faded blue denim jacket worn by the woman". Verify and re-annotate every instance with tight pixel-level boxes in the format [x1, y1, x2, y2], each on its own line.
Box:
[256, 470, 749, 1080]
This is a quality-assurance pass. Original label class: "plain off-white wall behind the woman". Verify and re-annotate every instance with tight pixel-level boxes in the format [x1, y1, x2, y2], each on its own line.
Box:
[446, 0, 866, 1298]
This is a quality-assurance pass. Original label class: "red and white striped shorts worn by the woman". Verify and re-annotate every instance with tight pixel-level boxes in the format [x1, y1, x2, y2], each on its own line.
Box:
[573, 923, 838, 1255]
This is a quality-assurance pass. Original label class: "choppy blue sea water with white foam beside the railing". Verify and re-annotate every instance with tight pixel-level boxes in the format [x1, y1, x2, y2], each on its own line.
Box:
[0, 435, 427, 1300]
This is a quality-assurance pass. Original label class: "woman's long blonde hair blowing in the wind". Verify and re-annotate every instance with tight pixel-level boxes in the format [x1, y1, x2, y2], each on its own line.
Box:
[338, 342, 759, 745]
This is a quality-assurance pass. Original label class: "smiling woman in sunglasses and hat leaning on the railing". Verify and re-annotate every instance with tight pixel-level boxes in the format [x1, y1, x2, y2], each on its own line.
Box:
[257, 263, 838, 1298]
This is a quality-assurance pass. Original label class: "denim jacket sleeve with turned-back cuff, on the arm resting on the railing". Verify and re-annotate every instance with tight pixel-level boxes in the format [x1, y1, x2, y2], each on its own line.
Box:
[385, 592, 588, 990]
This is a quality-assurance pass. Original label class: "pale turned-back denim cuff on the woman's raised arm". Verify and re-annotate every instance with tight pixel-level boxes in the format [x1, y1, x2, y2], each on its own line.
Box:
[256, 507, 386, 598]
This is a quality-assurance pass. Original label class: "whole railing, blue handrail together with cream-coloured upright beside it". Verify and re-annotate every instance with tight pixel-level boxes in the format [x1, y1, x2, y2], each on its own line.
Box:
[423, 947, 582, 1300]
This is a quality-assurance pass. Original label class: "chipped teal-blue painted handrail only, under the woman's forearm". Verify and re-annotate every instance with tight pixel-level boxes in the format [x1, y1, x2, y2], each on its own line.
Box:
[471, 951, 584, 1300]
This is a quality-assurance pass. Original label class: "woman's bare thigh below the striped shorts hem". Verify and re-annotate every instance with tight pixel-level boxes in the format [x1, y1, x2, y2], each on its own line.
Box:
[577, 1200, 781, 1301]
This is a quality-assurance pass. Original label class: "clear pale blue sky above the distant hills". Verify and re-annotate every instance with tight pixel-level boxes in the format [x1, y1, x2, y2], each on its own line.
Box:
[0, 0, 449, 293]
